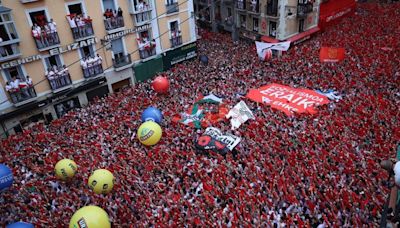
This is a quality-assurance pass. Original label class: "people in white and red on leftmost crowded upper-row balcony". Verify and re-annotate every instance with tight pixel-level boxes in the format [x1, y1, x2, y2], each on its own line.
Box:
[32, 19, 60, 49]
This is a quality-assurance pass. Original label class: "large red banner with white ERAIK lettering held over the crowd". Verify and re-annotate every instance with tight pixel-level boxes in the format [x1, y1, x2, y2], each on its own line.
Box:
[246, 84, 329, 116]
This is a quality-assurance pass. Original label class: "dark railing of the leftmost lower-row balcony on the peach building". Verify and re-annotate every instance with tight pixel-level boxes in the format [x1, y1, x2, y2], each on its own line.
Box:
[6, 81, 37, 106]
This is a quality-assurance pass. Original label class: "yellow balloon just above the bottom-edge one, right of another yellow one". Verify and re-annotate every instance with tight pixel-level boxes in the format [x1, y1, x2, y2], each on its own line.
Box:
[88, 169, 114, 194]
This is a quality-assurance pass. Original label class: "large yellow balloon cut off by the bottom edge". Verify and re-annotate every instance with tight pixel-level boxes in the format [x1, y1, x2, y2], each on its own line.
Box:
[69, 206, 111, 228]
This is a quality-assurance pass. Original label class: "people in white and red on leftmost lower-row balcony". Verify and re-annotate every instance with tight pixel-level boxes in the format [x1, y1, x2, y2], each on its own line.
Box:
[6, 76, 36, 103]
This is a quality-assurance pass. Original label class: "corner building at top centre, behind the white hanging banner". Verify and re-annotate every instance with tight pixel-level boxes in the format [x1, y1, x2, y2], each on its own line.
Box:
[195, 0, 320, 44]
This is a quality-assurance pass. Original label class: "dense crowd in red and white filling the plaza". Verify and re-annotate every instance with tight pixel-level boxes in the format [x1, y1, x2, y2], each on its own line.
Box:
[0, 3, 400, 227]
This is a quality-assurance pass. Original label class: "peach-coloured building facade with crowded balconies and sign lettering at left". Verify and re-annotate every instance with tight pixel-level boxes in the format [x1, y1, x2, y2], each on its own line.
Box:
[0, 0, 196, 136]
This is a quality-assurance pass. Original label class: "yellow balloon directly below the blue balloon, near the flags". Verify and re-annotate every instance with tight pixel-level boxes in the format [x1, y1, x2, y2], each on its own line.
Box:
[137, 121, 162, 146]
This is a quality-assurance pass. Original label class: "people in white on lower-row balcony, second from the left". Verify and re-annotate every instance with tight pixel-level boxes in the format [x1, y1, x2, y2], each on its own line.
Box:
[45, 65, 71, 90]
